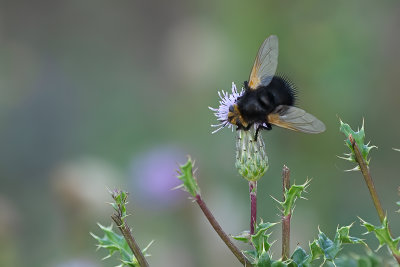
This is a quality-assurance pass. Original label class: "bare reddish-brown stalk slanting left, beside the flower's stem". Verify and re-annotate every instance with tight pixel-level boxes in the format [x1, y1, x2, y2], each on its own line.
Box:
[196, 195, 253, 266]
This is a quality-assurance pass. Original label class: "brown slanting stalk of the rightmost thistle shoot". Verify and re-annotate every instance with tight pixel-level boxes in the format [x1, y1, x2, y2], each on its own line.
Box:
[349, 135, 400, 264]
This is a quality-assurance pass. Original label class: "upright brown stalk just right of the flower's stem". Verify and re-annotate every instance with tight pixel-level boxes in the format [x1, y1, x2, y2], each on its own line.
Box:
[282, 165, 292, 261]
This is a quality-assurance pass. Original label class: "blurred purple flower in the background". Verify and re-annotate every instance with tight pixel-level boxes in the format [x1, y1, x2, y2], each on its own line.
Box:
[129, 146, 187, 209]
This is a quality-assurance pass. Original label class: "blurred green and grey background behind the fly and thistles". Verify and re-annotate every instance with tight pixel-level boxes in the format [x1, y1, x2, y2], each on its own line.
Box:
[0, 0, 400, 267]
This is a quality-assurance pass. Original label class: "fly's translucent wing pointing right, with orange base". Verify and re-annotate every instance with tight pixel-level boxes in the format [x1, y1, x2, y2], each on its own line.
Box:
[267, 105, 326, 134]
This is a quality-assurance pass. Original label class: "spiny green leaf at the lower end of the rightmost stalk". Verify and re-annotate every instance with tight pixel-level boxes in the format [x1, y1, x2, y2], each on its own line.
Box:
[360, 217, 400, 255]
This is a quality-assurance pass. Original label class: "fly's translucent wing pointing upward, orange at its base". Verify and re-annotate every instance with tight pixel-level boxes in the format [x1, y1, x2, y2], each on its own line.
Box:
[249, 35, 278, 90]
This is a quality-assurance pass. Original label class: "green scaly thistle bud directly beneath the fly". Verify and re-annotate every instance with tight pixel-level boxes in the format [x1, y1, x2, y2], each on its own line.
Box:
[235, 130, 269, 181]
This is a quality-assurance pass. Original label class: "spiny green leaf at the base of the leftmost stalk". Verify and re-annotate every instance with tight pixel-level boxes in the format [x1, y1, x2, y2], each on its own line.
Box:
[90, 223, 153, 267]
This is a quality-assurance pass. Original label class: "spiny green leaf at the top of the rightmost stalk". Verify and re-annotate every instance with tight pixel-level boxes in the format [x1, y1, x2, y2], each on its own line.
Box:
[339, 120, 376, 170]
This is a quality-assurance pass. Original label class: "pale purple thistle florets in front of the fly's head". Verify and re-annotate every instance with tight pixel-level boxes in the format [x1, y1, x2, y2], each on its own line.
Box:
[208, 82, 244, 133]
